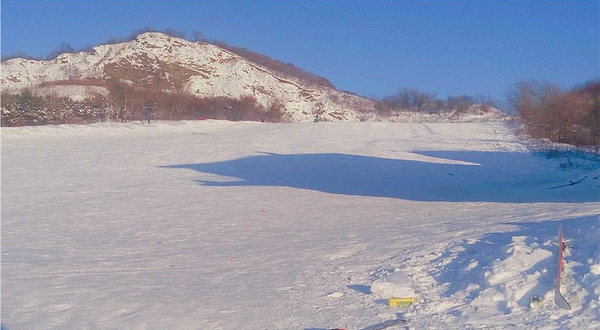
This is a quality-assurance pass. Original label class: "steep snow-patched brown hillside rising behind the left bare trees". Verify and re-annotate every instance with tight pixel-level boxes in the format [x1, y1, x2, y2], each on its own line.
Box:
[0, 32, 373, 121]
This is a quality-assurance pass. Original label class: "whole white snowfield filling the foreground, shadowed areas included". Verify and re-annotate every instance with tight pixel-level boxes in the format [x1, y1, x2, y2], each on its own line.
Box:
[1, 121, 600, 330]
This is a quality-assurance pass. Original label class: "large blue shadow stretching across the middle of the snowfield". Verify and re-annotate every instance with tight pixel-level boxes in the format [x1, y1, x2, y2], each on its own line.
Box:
[162, 151, 600, 203]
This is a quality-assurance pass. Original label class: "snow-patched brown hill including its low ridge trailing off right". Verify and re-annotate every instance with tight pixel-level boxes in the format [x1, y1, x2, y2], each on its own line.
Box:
[0, 32, 507, 122]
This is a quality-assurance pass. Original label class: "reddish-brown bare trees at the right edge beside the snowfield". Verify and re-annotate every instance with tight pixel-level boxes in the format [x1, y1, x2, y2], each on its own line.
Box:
[509, 81, 600, 148]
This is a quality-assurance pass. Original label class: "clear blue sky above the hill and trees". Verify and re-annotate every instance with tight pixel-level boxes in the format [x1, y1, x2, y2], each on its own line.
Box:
[1, 0, 600, 104]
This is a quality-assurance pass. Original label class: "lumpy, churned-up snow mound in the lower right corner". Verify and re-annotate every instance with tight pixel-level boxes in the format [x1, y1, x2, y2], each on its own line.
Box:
[398, 216, 600, 329]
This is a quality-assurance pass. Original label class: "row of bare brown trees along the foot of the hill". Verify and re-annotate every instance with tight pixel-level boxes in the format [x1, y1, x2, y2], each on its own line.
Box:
[1, 82, 286, 126]
